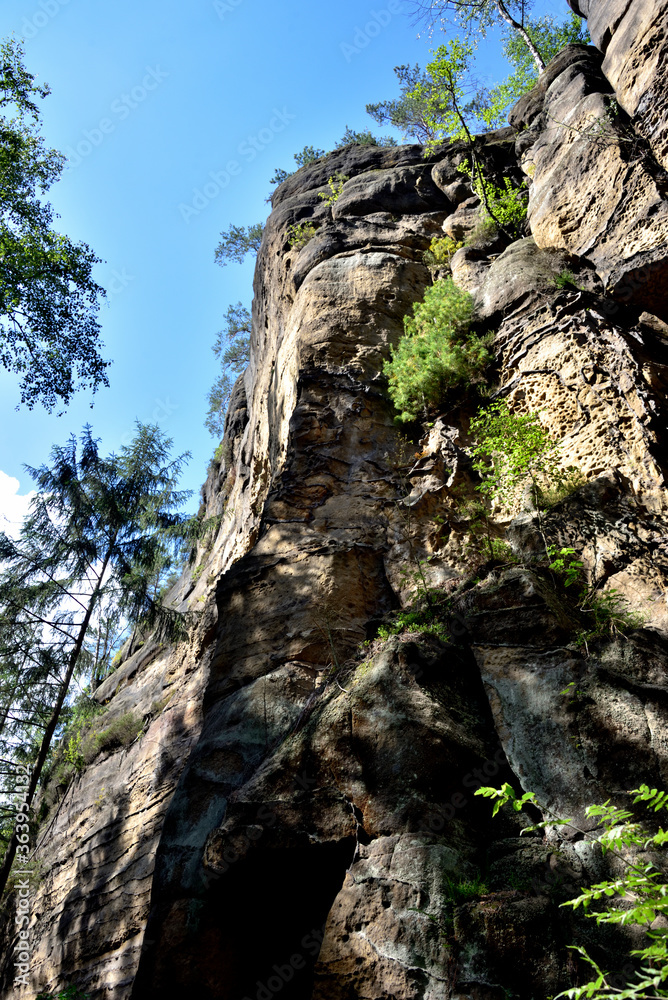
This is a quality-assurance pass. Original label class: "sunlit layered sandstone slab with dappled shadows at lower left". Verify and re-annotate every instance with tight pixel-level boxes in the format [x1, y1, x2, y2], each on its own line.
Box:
[3, 637, 211, 996]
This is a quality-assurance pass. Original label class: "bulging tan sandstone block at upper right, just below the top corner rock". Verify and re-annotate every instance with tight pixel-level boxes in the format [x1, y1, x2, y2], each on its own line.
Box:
[511, 45, 668, 318]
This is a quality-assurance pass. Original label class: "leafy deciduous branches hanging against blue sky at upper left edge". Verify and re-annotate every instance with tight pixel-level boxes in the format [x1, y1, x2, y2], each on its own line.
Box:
[0, 40, 109, 411]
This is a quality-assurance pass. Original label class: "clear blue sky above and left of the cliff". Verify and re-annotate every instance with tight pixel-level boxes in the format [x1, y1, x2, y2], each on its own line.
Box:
[0, 0, 568, 526]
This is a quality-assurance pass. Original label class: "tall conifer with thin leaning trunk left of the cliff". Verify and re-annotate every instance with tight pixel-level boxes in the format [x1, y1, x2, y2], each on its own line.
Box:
[0, 424, 193, 893]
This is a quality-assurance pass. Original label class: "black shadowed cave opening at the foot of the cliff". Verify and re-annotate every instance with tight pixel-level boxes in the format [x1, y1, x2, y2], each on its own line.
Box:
[188, 838, 355, 1000]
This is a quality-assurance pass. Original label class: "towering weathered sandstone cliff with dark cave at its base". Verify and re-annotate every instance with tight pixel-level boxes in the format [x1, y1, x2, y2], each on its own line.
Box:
[2, 7, 668, 1000]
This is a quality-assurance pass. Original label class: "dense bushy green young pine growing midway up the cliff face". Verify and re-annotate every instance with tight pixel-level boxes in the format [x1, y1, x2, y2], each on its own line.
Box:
[383, 278, 492, 421]
